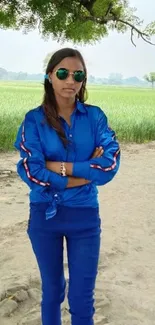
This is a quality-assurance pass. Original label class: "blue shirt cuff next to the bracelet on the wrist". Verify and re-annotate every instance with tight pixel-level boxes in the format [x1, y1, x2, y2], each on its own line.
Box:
[72, 161, 90, 180]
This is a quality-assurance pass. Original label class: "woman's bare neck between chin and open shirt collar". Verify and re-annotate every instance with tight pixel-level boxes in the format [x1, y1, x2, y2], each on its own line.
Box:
[56, 96, 75, 115]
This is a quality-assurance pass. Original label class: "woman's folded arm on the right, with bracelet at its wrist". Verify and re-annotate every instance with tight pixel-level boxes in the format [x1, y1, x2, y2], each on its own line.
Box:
[47, 110, 120, 185]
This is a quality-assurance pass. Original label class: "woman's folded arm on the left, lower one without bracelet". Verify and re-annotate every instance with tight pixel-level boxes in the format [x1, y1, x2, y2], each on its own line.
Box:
[14, 111, 92, 191]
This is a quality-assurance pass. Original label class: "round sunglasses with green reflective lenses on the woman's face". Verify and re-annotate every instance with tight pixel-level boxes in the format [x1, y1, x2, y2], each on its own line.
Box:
[55, 68, 86, 82]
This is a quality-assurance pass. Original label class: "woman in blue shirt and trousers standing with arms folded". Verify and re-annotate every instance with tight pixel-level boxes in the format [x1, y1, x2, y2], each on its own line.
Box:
[15, 48, 120, 325]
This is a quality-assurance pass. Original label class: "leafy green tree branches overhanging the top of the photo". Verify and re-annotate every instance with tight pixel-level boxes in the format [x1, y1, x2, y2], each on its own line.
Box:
[0, 0, 155, 46]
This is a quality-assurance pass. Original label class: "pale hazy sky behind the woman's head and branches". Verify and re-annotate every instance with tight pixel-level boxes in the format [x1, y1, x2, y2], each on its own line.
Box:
[0, 0, 155, 78]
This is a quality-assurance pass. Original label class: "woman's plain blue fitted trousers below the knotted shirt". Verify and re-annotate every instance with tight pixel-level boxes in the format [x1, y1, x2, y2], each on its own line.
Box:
[27, 203, 101, 325]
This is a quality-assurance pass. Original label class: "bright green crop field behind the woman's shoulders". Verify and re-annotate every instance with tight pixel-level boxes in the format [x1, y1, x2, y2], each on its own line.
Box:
[0, 82, 155, 151]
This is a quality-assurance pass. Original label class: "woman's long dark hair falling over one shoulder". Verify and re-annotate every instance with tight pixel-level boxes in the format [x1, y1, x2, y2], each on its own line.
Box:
[42, 48, 87, 147]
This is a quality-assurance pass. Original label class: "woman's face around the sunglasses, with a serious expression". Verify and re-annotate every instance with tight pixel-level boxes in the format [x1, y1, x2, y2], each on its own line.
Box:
[49, 57, 84, 98]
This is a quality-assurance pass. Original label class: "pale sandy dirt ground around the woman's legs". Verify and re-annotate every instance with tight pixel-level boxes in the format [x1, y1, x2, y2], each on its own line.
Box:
[0, 142, 155, 325]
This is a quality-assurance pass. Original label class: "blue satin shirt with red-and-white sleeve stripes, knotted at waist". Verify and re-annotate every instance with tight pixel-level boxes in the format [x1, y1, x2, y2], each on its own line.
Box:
[14, 101, 120, 219]
